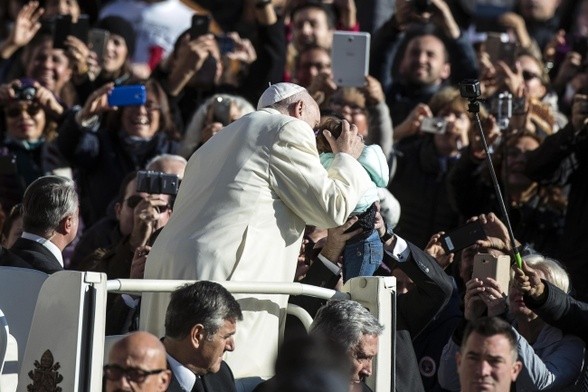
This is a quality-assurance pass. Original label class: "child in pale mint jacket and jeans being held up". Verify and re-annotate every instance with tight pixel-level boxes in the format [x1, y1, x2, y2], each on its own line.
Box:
[316, 116, 390, 281]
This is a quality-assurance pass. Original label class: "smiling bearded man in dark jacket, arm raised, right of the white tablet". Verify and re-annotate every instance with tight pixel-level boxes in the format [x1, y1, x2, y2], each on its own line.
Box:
[370, 0, 478, 136]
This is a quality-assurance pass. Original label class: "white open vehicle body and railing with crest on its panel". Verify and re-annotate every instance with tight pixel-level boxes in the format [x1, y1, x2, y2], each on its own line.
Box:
[0, 267, 395, 392]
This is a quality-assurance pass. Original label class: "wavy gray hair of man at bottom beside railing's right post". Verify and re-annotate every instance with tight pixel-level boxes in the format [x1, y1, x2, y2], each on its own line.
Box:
[309, 300, 384, 351]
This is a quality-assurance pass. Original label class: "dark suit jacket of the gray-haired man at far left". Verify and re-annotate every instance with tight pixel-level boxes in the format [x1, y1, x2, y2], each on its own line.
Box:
[0, 238, 63, 274]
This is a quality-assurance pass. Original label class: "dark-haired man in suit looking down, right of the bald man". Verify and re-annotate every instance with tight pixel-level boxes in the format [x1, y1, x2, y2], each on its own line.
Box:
[163, 281, 243, 392]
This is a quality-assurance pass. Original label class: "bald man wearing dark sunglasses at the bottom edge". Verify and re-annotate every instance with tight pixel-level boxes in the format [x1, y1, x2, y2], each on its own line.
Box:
[104, 331, 171, 392]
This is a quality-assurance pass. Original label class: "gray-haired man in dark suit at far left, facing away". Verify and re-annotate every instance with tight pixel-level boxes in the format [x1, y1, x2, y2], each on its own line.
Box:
[0, 176, 79, 274]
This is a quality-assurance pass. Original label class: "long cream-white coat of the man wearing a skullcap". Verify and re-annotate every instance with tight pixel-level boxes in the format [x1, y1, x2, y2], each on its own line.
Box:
[141, 109, 370, 377]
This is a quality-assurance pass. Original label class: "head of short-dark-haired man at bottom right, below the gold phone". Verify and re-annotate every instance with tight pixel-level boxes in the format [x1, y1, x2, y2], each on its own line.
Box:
[456, 317, 523, 392]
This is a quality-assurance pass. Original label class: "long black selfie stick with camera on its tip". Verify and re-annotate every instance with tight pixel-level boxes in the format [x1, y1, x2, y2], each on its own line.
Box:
[460, 79, 523, 269]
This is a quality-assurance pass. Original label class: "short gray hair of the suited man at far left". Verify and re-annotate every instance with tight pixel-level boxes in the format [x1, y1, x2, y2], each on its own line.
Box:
[22, 176, 79, 237]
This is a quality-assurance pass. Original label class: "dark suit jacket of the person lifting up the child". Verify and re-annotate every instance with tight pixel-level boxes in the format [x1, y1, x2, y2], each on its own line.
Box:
[290, 242, 452, 392]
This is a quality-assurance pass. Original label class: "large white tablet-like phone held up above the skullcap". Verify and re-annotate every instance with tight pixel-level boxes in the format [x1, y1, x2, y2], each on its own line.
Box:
[331, 31, 370, 87]
